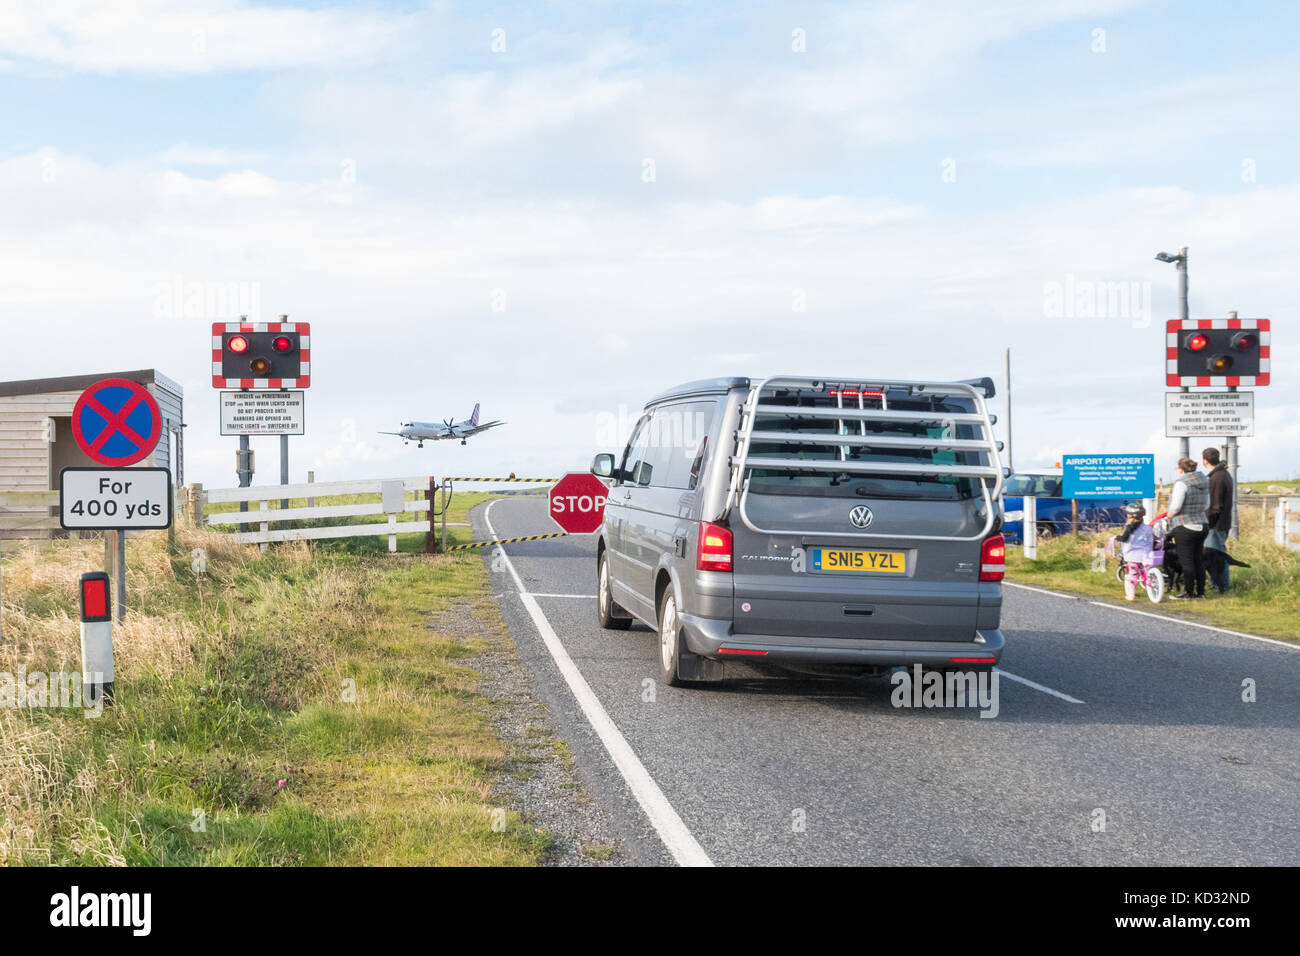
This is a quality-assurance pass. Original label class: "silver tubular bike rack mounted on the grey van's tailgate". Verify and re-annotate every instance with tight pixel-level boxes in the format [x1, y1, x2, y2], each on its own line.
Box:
[724, 375, 1006, 541]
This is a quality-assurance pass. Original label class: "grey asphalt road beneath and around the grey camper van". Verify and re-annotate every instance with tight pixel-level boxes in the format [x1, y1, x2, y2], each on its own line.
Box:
[472, 498, 1300, 865]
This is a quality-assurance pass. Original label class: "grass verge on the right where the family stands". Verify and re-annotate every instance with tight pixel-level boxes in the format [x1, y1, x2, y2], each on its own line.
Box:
[1006, 511, 1300, 640]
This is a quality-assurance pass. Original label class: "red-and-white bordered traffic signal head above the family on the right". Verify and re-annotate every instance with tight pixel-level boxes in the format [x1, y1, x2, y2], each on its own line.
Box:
[1165, 319, 1269, 386]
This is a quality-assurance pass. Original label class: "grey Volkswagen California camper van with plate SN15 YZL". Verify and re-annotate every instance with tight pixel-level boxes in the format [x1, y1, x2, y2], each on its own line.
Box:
[592, 376, 1006, 685]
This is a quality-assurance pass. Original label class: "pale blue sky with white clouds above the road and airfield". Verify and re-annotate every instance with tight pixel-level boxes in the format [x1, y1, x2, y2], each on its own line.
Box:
[0, 0, 1300, 488]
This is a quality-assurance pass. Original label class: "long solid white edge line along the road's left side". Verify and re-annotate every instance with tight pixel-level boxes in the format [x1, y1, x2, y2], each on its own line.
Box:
[484, 499, 714, 866]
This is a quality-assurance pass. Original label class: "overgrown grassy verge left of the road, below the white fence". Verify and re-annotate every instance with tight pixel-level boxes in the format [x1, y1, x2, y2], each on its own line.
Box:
[0, 494, 549, 866]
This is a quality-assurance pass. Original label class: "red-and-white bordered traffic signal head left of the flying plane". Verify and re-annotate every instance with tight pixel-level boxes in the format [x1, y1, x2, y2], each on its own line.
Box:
[212, 323, 311, 389]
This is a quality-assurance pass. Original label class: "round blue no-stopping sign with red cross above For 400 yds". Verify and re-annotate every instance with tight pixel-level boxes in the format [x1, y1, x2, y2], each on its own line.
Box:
[73, 378, 163, 468]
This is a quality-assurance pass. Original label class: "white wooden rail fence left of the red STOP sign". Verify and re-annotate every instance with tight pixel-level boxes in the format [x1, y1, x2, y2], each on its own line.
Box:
[191, 476, 456, 553]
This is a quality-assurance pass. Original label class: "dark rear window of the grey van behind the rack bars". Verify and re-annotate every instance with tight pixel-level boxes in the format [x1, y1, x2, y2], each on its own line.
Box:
[750, 393, 984, 501]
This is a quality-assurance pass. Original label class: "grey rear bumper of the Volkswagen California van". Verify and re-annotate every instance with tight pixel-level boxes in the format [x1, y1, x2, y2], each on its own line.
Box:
[681, 614, 1005, 666]
